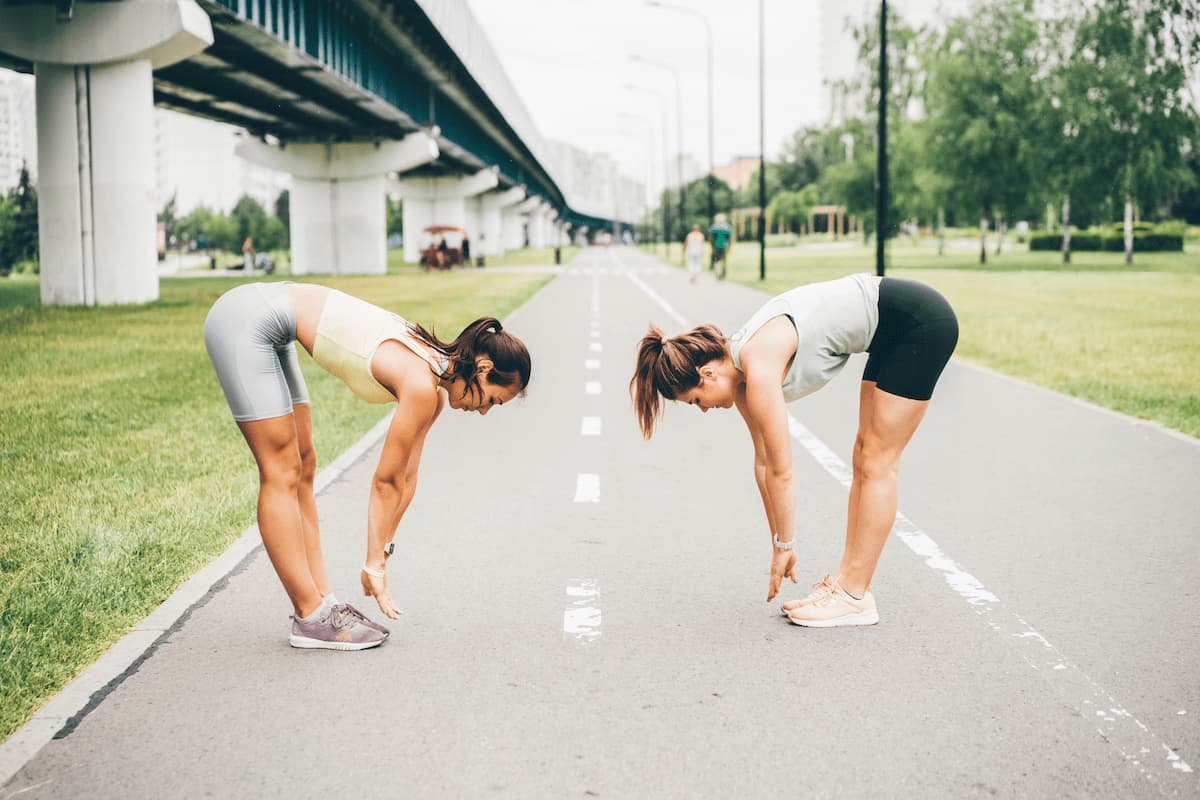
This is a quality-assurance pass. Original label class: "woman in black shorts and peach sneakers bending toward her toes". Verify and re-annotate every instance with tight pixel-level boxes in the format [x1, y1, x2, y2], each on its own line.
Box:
[630, 275, 959, 627]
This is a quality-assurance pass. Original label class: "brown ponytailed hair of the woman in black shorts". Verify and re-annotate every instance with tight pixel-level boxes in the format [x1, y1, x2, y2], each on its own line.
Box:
[629, 324, 728, 439]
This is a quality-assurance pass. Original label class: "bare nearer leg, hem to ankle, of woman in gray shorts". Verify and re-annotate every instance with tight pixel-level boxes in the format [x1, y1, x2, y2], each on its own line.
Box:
[238, 414, 322, 616]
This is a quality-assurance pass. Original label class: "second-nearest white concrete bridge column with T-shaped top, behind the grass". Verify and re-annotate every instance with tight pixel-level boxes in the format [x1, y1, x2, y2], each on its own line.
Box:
[236, 132, 438, 275]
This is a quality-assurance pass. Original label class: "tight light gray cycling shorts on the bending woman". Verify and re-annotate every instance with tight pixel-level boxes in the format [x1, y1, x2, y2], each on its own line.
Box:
[204, 283, 308, 422]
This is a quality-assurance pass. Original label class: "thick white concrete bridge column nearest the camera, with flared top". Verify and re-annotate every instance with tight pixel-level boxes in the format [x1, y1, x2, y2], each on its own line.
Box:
[0, 0, 212, 306]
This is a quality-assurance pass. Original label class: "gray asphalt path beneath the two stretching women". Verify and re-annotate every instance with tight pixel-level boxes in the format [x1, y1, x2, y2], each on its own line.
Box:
[0, 248, 1200, 799]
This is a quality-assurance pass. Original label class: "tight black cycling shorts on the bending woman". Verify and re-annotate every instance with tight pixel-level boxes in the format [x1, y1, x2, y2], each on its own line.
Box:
[863, 278, 959, 401]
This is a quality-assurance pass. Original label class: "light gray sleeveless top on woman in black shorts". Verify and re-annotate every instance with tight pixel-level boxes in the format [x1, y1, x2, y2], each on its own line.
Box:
[730, 273, 880, 402]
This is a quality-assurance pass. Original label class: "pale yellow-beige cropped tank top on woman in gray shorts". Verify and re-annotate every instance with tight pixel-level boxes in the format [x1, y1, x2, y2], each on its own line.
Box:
[312, 289, 450, 403]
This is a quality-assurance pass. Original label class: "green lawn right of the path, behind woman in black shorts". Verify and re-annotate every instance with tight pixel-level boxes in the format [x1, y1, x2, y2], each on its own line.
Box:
[715, 241, 1200, 437]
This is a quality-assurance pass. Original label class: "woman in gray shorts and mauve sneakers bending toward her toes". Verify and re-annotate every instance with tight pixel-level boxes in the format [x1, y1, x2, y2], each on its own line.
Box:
[204, 283, 530, 650]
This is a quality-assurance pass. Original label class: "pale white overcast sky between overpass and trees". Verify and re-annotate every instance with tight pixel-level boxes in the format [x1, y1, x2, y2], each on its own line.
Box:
[467, 0, 961, 191]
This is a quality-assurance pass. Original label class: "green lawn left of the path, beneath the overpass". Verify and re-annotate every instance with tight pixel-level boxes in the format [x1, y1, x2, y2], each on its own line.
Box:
[0, 270, 550, 740]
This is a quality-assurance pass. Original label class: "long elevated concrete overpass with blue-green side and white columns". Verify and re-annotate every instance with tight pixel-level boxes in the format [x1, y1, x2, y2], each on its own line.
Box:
[0, 0, 632, 305]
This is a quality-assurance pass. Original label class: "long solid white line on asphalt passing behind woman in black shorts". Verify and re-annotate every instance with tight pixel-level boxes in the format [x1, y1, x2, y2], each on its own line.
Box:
[626, 260, 1193, 782]
